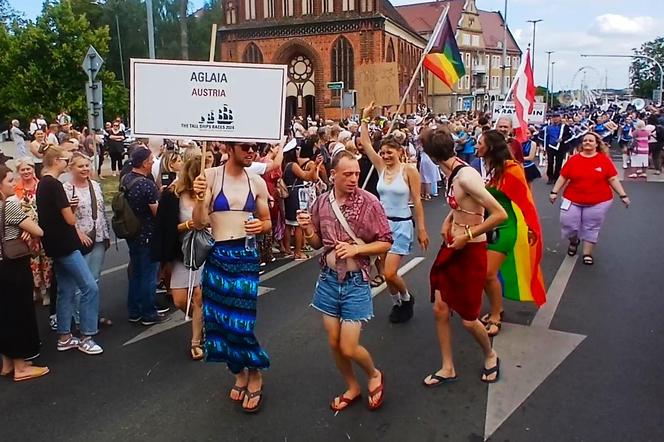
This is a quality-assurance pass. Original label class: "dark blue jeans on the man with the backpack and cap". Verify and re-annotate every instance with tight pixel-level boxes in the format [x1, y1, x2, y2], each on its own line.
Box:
[127, 240, 159, 320]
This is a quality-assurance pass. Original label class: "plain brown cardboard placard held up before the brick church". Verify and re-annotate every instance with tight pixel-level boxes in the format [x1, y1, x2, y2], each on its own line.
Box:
[355, 63, 401, 109]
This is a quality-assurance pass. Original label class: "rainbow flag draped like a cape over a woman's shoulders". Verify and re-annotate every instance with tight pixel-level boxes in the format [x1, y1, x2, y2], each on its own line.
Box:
[498, 160, 546, 306]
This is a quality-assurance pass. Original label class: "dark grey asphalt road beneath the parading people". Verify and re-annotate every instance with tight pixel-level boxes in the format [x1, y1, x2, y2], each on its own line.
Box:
[0, 177, 664, 442]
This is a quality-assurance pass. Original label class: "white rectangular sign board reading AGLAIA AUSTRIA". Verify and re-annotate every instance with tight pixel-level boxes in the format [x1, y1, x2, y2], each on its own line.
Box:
[130, 58, 287, 143]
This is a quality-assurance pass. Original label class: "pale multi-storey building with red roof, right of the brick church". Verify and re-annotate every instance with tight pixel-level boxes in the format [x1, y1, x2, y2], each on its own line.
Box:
[397, 0, 521, 113]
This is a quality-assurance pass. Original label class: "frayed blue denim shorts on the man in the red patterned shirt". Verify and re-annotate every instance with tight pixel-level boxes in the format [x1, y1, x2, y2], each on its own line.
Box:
[311, 268, 373, 321]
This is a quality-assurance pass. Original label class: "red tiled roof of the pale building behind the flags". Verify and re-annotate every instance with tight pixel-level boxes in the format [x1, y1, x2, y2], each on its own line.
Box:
[396, 0, 521, 52]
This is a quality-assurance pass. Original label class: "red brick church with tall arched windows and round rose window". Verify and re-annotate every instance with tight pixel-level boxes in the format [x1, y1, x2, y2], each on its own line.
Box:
[218, 0, 427, 119]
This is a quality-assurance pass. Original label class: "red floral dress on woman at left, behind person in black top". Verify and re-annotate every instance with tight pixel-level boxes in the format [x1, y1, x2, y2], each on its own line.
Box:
[12, 181, 53, 295]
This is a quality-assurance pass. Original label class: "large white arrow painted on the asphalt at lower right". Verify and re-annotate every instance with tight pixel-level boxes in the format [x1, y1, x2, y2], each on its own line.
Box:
[484, 256, 586, 440]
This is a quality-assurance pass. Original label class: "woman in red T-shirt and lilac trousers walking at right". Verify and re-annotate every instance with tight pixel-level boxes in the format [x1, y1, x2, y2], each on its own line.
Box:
[549, 132, 629, 265]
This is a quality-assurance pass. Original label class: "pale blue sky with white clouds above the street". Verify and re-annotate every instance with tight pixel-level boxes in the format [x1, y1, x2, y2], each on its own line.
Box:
[9, 0, 664, 90]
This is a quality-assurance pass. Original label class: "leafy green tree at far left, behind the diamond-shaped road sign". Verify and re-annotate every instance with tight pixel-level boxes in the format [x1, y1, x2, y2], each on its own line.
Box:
[0, 1, 128, 125]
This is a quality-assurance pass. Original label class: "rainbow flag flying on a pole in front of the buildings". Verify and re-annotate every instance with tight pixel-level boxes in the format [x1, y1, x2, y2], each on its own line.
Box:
[424, 14, 466, 88]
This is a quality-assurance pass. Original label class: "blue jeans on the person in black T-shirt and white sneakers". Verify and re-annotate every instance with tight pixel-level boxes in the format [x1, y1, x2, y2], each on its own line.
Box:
[53, 250, 99, 336]
